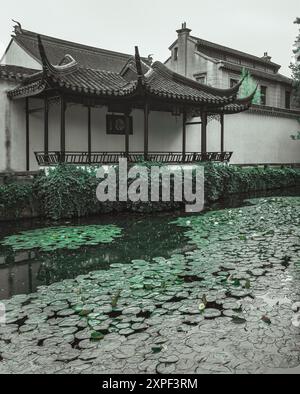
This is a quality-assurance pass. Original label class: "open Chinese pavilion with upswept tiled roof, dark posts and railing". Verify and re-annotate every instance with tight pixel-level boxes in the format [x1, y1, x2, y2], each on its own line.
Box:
[8, 36, 255, 170]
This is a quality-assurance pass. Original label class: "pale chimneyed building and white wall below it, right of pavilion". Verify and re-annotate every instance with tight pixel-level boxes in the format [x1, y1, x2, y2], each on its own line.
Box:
[165, 23, 300, 164]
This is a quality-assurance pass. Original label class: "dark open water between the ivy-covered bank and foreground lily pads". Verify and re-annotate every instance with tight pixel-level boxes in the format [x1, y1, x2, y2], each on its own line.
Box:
[0, 188, 300, 299]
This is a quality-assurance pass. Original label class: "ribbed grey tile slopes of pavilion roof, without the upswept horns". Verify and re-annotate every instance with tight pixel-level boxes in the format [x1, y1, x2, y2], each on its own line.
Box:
[10, 63, 244, 104]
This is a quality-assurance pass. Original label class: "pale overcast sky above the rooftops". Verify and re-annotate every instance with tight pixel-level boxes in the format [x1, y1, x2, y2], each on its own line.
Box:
[0, 0, 300, 75]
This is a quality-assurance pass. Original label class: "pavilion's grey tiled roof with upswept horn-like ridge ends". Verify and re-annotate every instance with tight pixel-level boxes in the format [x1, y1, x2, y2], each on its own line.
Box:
[9, 37, 251, 111]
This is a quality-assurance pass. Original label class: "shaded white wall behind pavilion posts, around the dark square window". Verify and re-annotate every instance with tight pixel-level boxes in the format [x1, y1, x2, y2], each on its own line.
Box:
[7, 99, 182, 171]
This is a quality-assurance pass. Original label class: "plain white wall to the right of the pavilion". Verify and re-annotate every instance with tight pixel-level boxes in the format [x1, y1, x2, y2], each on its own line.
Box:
[204, 113, 300, 164]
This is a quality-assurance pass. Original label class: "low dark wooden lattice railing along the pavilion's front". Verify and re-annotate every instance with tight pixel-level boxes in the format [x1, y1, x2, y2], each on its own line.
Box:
[35, 152, 232, 167]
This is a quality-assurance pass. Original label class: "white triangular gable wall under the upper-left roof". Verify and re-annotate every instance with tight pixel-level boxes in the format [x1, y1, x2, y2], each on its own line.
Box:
[1, 40, 42, 70]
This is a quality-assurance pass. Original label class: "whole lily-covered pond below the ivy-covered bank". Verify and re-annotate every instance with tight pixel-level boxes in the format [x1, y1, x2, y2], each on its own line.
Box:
[0, 189, 300, 374]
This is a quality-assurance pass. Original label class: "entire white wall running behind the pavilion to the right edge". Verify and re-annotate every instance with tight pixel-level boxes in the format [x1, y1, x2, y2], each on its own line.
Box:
[0, 94, 300, 171]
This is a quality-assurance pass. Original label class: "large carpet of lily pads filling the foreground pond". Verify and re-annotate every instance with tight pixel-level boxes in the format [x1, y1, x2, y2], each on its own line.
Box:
[0, 198, 300, 374]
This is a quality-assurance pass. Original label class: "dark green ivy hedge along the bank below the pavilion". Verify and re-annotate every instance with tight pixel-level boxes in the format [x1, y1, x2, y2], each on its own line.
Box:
[0, 163, 300, 220]
